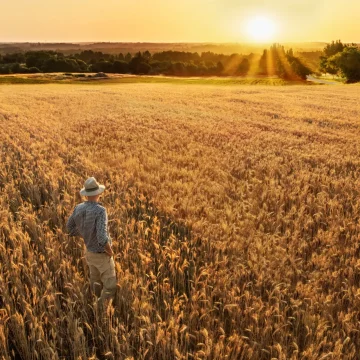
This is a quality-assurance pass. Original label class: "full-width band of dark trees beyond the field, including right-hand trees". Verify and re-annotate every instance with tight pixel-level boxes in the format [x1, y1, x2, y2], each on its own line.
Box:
[0, 41, 360, 81]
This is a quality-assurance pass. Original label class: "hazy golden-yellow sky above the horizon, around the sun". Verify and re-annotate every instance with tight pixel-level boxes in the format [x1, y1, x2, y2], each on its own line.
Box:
[0, 0, 360, 42]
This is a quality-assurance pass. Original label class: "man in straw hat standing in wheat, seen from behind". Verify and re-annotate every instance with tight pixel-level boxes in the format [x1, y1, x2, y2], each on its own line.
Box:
[66, 177, 117, 304]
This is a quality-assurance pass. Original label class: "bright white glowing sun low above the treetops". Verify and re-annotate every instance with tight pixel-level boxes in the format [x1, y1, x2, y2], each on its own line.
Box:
[246, 15, 277, 42]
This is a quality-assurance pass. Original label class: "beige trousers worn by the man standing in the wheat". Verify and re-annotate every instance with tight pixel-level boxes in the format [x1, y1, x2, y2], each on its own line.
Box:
[85, 251, 117, 303]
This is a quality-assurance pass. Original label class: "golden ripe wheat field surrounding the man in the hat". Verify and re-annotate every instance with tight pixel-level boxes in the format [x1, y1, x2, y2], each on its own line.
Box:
[0, 83, 360, 360]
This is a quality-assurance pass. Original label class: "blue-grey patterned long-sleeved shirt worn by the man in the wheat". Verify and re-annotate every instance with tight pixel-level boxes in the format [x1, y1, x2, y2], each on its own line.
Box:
[66, 201, 112, 253]
